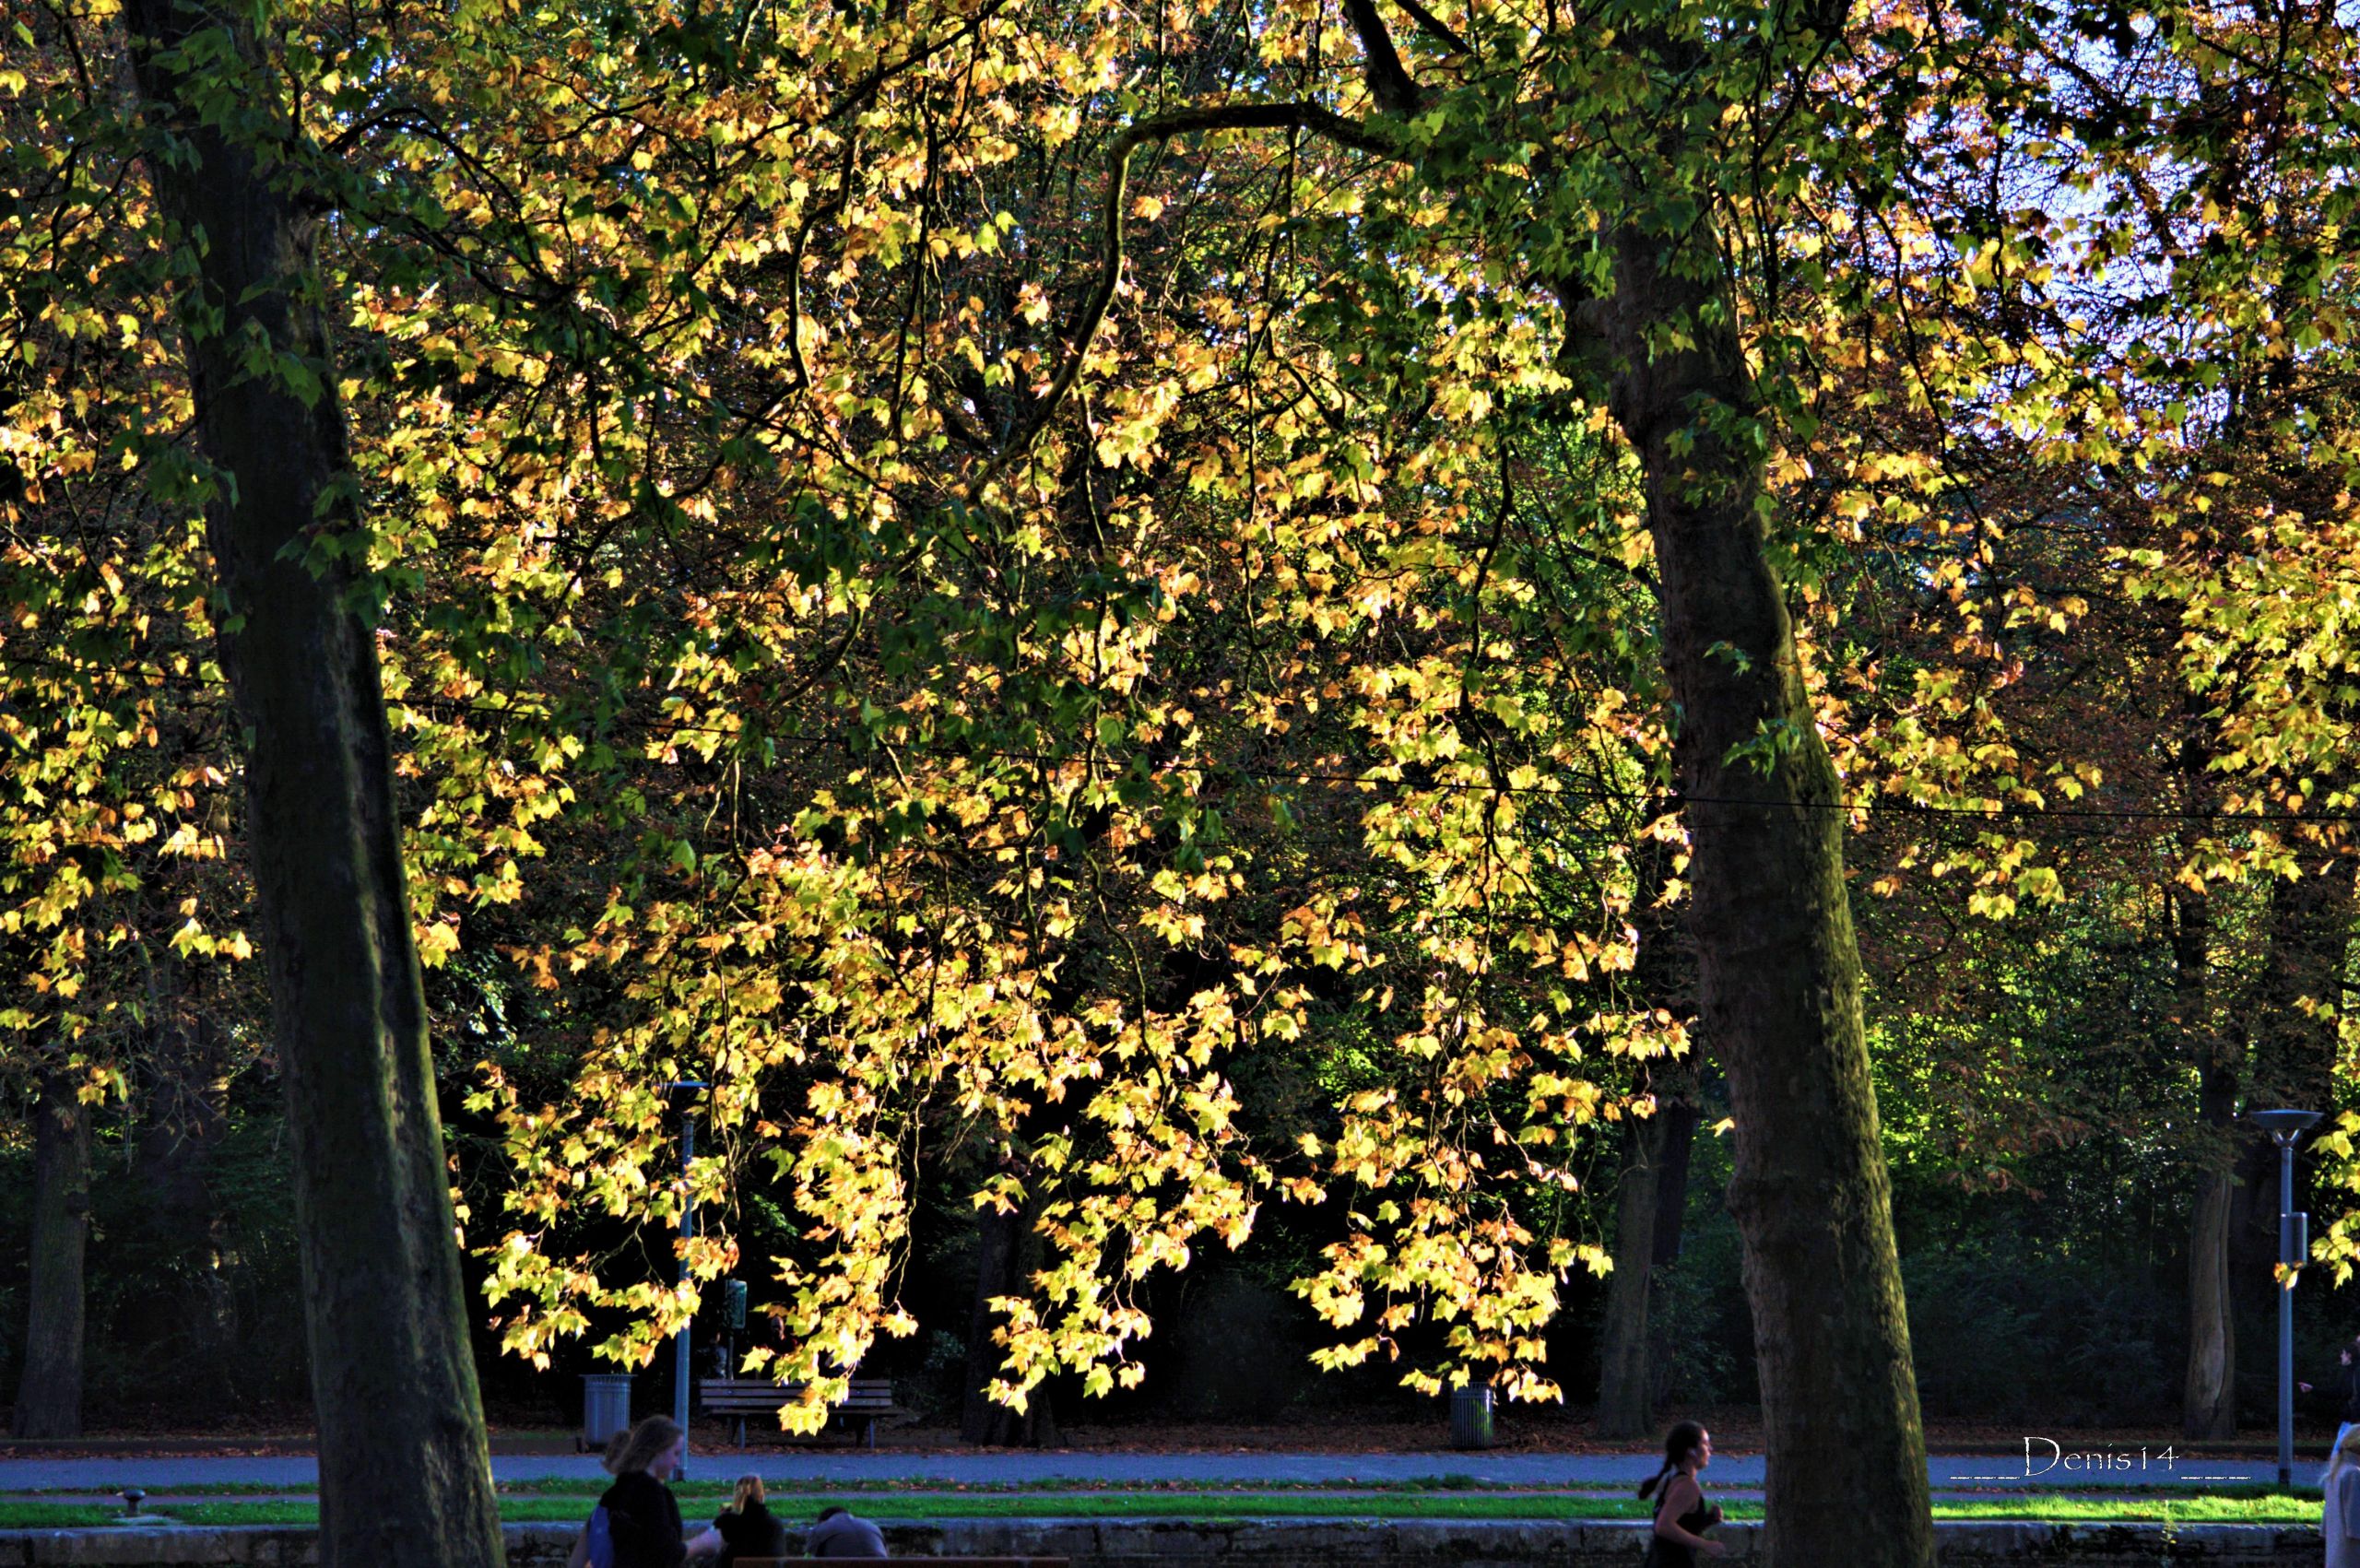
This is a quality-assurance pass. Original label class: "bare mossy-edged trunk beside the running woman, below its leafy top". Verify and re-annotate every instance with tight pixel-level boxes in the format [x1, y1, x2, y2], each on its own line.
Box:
[1560, 219, 1933, 1568]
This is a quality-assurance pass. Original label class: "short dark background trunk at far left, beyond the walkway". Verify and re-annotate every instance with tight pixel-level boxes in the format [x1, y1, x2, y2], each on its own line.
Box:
[9, 1072, 89, 1438]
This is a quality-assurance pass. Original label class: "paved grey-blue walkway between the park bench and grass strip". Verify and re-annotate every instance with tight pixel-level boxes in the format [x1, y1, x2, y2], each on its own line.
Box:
[0, 1445, 2319, 1495]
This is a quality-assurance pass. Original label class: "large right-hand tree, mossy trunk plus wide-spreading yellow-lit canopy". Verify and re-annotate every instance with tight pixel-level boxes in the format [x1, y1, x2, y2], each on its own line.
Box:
[22, 0, 2334, 1563]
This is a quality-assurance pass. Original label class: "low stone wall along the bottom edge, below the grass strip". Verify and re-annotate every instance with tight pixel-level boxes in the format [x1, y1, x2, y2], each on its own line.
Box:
[0, 1518, 2322, 1568]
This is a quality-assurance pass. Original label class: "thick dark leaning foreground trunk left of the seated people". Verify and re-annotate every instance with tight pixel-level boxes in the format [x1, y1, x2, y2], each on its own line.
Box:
[125, 0, 502, 1568]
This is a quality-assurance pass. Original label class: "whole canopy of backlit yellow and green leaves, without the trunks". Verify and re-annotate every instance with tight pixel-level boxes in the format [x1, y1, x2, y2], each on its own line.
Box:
[0, 0, 2360, 1421]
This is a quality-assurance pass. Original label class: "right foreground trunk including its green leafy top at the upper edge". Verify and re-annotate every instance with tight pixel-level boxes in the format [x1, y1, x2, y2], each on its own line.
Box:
[1312, 7, 1933, 1563]
